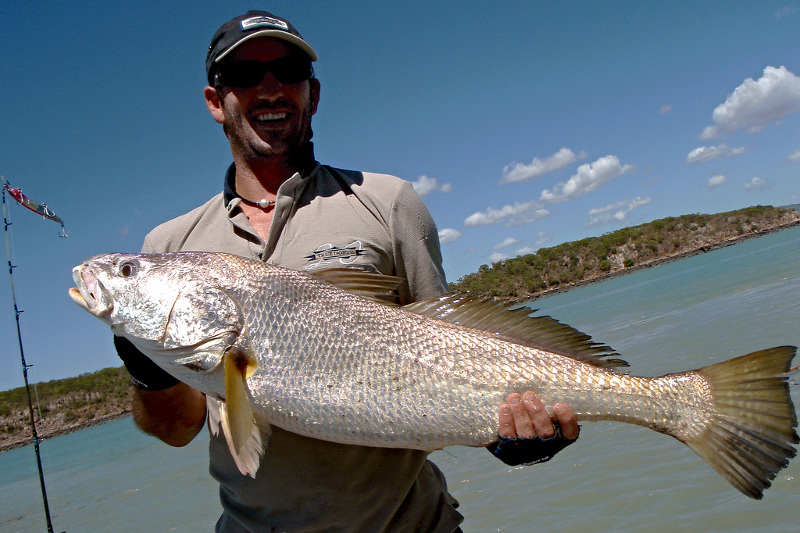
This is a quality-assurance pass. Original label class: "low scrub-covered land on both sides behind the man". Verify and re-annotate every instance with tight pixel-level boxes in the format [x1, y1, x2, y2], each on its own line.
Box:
[0, 206, 800, 451]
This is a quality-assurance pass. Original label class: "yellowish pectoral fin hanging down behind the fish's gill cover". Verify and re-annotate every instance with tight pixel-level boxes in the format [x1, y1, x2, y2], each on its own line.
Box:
[219, 346, 263, 477]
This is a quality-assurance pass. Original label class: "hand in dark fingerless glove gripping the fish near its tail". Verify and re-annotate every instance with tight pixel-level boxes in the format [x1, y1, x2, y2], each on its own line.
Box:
[488, 391, 580, 465]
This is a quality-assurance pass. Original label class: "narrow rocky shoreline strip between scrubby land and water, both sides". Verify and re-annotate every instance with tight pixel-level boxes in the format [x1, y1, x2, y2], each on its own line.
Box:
[0, 214, 800, 453]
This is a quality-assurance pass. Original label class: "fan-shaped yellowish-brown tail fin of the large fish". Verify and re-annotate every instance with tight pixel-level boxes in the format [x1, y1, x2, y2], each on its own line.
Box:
[685, 346, 798, 500]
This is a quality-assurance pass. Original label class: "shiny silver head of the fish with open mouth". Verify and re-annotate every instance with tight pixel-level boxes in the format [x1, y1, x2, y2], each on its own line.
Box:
[70, 253, 243, 379]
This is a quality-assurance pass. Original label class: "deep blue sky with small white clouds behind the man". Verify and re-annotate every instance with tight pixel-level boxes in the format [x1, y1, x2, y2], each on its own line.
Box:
[0, 0, 800, 390]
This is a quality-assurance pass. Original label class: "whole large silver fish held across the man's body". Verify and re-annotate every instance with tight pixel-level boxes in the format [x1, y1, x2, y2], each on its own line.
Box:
[70, 252, 798, 498]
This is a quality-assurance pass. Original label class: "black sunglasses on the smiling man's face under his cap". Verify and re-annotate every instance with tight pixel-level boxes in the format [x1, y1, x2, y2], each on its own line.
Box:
[214, 56, 314, 89]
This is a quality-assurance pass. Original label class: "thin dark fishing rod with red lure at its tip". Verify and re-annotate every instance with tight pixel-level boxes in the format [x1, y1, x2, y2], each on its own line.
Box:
[0, 176, 68, 533]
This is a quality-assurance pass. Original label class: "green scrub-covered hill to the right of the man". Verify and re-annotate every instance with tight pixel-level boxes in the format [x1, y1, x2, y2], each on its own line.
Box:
[450, 206, 800, 299]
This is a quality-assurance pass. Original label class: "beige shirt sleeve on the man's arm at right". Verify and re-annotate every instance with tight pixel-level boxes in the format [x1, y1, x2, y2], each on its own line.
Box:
[389, 182, 447, 305]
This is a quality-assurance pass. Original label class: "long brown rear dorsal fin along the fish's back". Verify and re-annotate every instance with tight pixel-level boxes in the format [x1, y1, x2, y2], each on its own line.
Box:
[403, 292, 628, 368]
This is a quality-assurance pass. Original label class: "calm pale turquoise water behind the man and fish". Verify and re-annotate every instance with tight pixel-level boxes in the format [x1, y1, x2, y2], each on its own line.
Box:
[0, 228, 800, 533]
